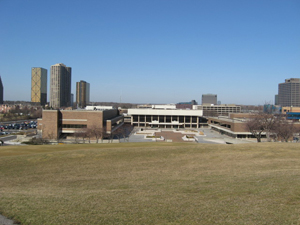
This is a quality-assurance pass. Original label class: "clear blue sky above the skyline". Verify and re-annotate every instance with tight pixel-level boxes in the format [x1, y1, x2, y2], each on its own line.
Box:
[0, 0, 300, 105]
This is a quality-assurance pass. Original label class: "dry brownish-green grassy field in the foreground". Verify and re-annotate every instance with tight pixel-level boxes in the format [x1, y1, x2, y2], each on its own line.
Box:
[0, 143, 300, 225]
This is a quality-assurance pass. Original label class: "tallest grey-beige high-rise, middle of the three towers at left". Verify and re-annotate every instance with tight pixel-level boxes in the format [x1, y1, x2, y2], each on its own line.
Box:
[50, 63, 71, 108]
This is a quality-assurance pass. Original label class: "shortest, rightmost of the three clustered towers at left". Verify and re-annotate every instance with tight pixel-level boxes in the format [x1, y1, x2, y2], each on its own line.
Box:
[76, 80, 90, 108]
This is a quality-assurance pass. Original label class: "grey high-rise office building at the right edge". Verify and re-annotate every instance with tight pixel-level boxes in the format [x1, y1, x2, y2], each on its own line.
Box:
[278, 78, 300, 107]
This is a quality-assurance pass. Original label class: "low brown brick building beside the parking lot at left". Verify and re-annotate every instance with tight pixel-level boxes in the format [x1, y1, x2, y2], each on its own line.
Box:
[38, 109, 124, 139]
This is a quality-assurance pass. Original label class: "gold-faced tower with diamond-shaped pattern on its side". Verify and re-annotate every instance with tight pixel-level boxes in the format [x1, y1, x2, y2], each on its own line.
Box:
[31, 67, 47, 105]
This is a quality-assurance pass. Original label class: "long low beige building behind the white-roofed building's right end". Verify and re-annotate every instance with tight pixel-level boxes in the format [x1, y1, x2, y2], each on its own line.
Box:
[193, 104, 241, 116]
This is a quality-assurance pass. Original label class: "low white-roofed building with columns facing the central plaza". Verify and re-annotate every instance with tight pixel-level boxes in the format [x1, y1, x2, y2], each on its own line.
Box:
[127, 107, 207, 128]
